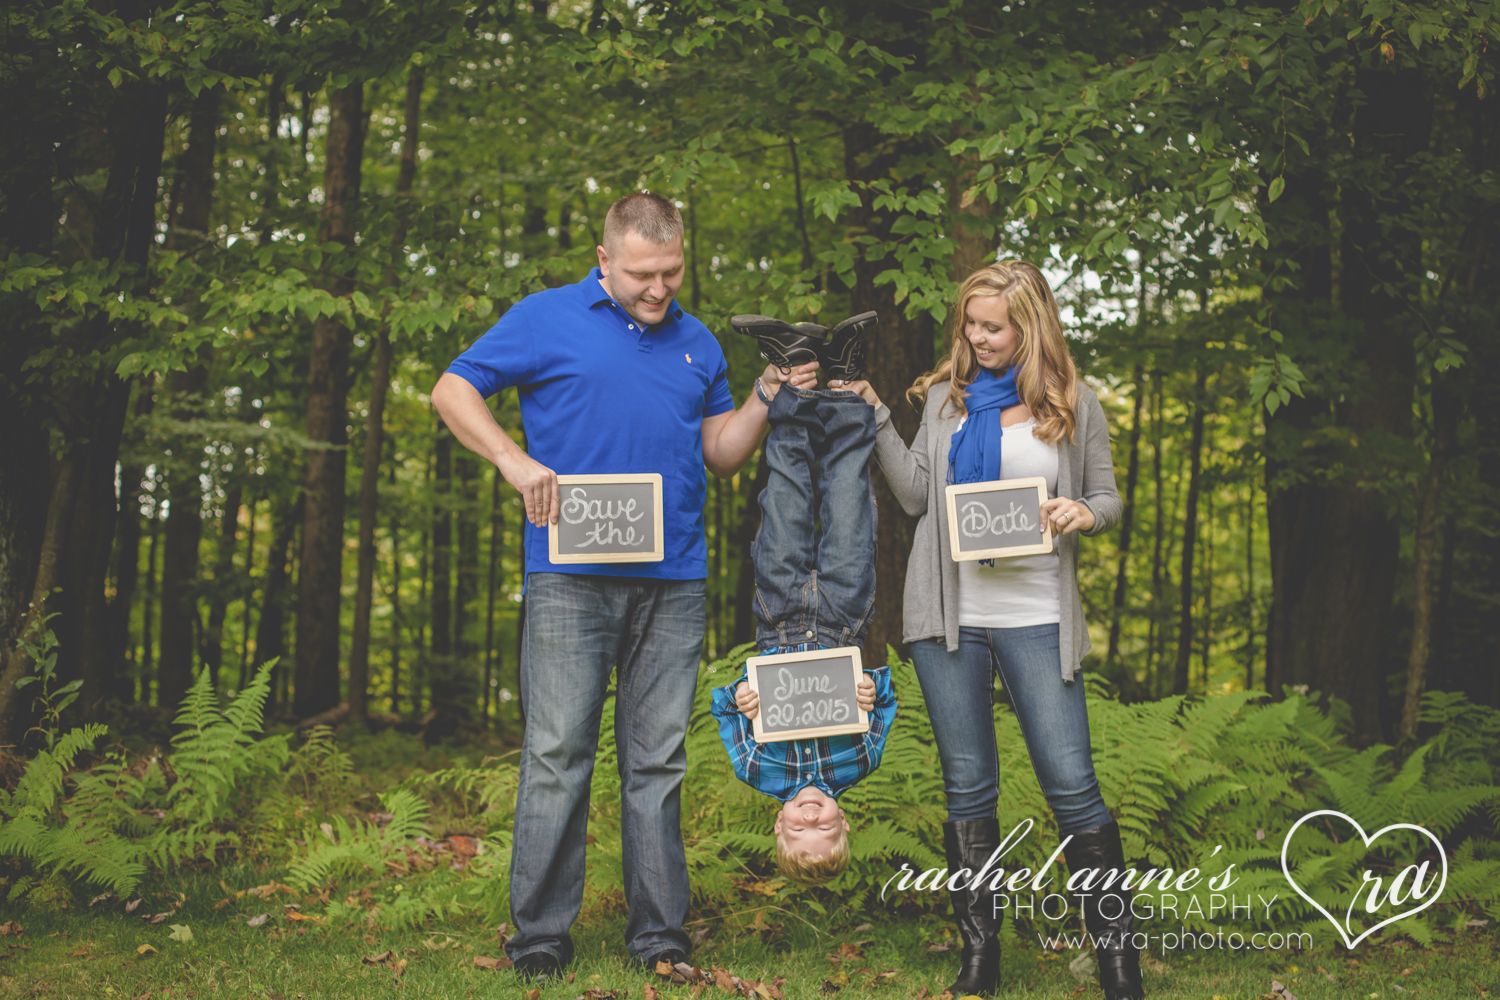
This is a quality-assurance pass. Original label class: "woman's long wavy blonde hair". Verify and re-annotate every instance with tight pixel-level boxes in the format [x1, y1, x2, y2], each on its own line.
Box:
[906, 261, 1079, 444]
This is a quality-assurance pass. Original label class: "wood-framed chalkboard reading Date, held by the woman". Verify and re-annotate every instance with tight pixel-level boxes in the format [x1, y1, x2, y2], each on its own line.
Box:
[948, 475, 1052, 562]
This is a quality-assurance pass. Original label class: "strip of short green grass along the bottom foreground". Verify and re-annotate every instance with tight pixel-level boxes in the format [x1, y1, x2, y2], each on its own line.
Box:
[0, 870, 1500, 1000]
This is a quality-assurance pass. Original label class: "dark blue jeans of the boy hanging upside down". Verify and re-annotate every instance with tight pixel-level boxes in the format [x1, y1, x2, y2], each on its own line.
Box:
[750, 385, 876, 649]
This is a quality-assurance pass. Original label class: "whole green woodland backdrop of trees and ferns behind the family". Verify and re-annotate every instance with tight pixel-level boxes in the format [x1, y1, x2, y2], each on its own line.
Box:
[0, 0, 1500, 996]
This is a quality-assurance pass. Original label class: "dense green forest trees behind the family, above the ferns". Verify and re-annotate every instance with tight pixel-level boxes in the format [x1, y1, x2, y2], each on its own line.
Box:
[11, 0, 1500, 739]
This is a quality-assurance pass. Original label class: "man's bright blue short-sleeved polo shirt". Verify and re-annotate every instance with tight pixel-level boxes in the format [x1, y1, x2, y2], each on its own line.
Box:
[449, 267, 735, 580]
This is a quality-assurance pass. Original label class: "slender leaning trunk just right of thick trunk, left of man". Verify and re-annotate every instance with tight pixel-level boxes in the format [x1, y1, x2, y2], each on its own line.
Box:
[350, 66, 425, 726]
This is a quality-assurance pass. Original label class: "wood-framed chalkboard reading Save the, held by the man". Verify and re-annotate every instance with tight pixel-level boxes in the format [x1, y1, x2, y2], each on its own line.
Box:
[548, 472, 666, 562]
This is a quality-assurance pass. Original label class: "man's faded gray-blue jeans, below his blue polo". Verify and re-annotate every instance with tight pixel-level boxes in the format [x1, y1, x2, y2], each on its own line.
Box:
[506, 573, 705, 964]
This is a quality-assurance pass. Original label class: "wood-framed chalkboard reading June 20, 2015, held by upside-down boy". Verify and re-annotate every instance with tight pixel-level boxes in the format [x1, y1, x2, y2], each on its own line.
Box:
[746, 646, 870, 744]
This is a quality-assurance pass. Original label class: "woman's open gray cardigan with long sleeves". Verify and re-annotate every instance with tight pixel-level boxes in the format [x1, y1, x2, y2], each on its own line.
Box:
[875, 382, 1124, 681]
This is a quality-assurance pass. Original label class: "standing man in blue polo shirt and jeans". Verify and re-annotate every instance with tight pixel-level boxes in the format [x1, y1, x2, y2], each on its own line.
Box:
[432, 193, 818, 979]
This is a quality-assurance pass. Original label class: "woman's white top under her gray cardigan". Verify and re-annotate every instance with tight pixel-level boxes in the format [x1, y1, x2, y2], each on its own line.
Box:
[959, 420, 1062, 628]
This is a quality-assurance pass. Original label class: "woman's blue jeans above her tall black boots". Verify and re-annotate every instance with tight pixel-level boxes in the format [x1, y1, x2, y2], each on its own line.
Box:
[912, 625, 1110, 835]
